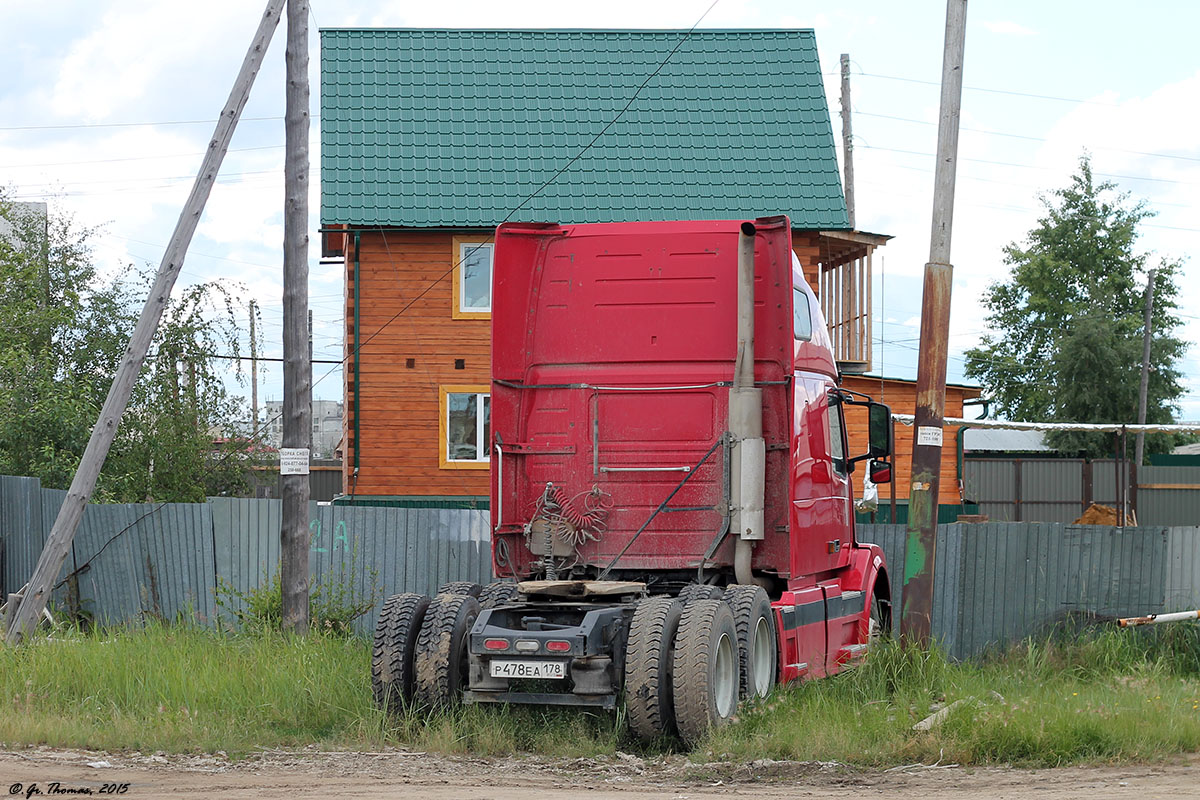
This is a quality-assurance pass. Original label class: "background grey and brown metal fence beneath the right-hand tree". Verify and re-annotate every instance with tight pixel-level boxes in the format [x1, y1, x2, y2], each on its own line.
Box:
[962, 458, 1200, 525]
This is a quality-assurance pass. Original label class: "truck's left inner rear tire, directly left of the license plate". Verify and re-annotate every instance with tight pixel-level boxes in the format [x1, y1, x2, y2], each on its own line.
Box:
[413, 594, 479, 709]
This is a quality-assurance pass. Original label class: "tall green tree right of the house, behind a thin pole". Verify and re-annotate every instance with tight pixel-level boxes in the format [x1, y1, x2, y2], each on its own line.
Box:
[966, 155, 1186, 457]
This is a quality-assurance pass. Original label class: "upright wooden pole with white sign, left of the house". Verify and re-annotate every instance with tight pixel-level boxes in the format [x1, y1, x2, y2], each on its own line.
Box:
[280, 0, 312, 633]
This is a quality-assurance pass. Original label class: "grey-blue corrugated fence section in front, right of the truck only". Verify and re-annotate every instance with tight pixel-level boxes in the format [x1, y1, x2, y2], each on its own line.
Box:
[858, 523, 1200, 658]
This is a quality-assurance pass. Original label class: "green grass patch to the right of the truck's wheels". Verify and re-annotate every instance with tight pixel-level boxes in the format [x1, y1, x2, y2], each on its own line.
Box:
[704, 625, 1200, 768]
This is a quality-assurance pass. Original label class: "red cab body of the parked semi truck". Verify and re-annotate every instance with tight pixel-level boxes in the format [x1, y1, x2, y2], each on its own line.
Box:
[491, 217, 882, 679]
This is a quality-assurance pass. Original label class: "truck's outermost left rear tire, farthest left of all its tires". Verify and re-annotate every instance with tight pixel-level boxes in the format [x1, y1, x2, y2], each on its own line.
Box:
[371, 594, 430, 714]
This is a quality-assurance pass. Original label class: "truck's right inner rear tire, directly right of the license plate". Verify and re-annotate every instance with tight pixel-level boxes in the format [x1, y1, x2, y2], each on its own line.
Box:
[625, 597, 683, 739]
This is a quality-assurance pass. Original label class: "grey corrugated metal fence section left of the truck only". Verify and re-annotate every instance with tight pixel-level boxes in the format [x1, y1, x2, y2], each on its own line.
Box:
[0, 477, 492, 632]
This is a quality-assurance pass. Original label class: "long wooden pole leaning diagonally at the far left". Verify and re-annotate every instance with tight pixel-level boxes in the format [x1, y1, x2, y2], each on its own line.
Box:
[6, 0, 283, 644]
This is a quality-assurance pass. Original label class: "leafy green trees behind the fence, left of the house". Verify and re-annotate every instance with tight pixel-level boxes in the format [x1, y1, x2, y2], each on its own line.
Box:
[0, 191, 261, 503]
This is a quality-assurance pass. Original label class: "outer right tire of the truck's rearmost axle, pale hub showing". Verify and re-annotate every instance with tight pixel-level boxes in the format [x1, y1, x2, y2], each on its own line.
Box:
[673, 600, 740, 745]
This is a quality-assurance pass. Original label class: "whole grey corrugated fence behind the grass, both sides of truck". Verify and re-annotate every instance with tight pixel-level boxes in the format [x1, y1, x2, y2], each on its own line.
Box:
[0, 477, 1200, 658]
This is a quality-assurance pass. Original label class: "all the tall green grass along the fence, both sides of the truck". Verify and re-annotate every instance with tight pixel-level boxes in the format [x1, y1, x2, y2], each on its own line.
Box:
[0, 624, 1200, 768]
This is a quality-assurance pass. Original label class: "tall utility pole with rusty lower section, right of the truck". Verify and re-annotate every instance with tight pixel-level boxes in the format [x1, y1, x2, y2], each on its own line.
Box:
[900, 0, 967, 646]
